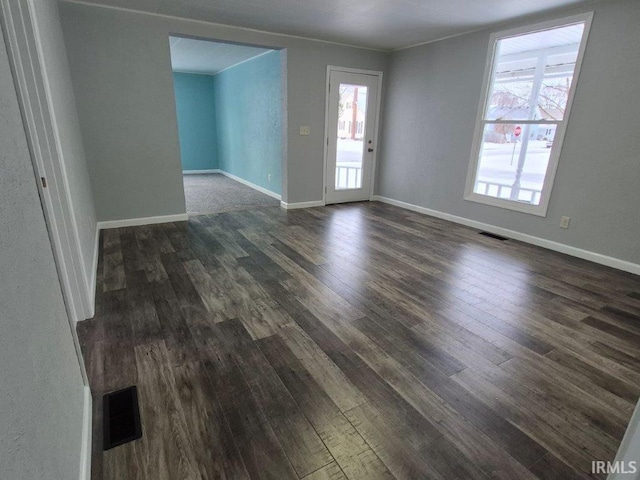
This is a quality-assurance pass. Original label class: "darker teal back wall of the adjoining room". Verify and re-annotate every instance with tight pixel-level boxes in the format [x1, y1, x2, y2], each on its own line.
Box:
[173, 72, 219, 170]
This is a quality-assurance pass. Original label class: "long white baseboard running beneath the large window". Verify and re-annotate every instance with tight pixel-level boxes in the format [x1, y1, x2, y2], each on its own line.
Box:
[373, 195, 640, 275]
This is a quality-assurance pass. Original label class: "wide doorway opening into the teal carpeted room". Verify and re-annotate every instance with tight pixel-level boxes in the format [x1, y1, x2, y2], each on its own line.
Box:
[169, 36, 286, 215]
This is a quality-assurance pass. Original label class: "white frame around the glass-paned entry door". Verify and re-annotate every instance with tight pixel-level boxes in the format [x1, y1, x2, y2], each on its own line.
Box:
[322, 65, 383, 205]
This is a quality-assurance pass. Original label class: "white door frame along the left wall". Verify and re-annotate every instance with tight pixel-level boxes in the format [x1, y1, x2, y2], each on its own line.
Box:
[0, 0, 94, 374]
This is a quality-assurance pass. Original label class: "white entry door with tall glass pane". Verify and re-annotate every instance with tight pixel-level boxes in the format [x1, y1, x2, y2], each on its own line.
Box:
[325, 67, 381, 204]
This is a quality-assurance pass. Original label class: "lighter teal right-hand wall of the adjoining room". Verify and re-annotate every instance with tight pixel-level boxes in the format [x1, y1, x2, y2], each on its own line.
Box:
[213, 51, 282, 194]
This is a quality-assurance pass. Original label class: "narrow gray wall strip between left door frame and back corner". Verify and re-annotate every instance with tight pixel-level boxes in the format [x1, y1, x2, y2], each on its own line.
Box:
[33, 0, 97, 296]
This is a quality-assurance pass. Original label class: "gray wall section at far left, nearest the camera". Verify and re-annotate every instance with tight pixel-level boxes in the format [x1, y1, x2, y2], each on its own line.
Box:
[0, 20, 84, 480]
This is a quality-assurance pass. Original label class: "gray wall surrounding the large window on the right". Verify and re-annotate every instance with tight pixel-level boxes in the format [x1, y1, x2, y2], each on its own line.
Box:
[376, 0, 640, 263]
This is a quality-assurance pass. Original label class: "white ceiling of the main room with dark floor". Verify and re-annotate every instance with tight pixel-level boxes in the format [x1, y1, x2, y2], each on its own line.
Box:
[65, 0, 595, 50]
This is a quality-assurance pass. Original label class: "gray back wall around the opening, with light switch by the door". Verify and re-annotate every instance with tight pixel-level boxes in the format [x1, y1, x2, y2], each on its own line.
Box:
[60, 3, 388, 220]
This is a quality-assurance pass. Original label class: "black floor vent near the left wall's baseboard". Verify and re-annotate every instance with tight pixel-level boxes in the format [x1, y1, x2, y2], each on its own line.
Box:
[102, 386, 142, 450]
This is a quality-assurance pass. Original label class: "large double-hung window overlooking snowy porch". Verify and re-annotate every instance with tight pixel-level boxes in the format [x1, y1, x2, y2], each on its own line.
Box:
[465, 14, 591, 215]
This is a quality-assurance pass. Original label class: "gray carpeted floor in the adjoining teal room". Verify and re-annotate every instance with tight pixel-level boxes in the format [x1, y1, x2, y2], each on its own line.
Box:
[182, 173, 280, 215]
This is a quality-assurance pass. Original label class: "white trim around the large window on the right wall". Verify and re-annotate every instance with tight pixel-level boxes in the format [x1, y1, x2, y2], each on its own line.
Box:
[464, 12, 593, 217]
